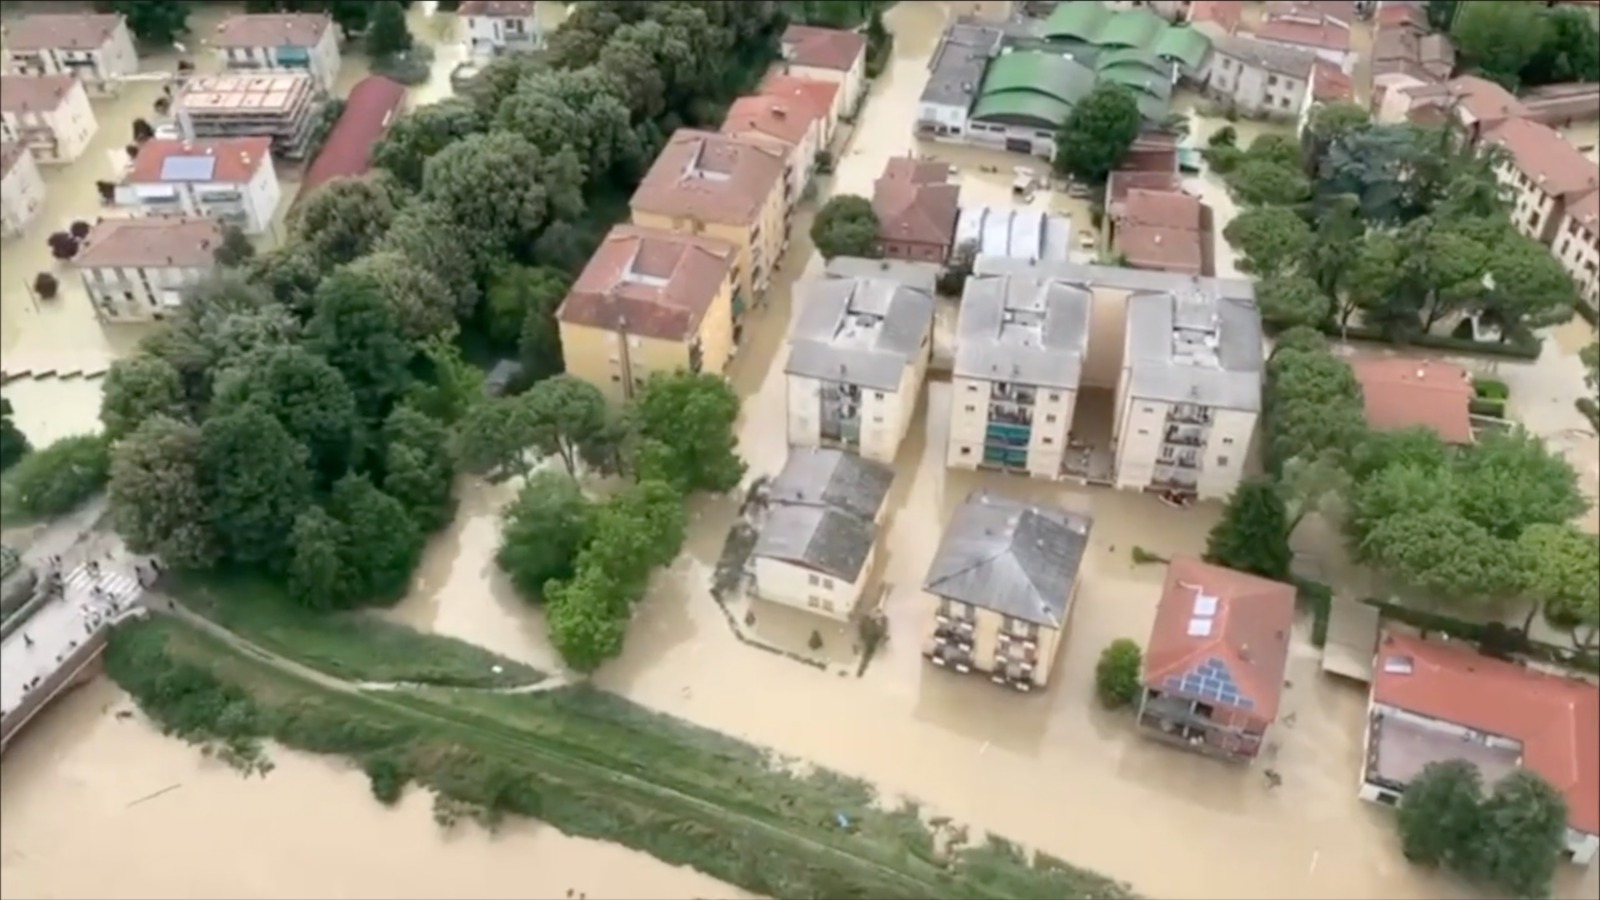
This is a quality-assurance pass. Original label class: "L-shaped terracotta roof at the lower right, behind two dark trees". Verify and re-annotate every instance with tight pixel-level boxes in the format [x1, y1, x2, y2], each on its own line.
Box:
[1373, 633, 1600, 834]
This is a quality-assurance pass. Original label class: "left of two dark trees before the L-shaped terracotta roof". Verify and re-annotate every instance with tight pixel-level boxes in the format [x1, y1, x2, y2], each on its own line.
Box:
[1395, 759, 1483, 866]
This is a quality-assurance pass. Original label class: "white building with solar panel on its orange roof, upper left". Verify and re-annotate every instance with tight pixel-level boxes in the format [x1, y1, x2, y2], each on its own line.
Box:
[115, 138, 283, 234]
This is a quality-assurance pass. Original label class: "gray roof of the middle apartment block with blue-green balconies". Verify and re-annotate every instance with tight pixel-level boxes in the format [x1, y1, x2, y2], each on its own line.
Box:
[954, 269, 1091, 391]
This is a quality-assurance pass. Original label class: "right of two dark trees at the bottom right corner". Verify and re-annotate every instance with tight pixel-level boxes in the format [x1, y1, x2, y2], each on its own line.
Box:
[1462, 769, 1566, 897]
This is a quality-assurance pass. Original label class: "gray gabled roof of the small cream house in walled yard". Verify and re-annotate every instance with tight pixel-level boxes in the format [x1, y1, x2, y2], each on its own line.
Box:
[752, 447, 894, 581]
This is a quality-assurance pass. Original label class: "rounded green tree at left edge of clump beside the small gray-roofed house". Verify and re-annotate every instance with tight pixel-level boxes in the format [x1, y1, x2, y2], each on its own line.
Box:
[494, 471, 592, 601]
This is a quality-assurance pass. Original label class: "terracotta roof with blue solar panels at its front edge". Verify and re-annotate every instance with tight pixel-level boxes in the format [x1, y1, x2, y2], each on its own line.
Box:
[1144, 557, 1294, 724]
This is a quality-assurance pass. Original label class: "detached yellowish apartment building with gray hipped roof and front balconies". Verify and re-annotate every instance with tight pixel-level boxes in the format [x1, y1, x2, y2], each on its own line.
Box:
[922, 492, 1091, 692]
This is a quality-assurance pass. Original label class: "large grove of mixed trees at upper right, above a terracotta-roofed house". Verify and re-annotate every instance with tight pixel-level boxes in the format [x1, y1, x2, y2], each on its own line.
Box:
[1206, 106, 1576, 341]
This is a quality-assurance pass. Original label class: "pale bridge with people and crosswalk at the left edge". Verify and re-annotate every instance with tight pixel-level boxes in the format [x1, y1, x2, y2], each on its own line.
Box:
[0, 559, 147, 753]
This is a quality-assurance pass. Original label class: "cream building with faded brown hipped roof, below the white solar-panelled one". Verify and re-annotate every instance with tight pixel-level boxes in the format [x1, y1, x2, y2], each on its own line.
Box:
[72, 218, 222, 322]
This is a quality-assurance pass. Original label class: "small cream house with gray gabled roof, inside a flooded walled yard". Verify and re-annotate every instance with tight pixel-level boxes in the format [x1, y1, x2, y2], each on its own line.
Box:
[747, 447, 894, 621]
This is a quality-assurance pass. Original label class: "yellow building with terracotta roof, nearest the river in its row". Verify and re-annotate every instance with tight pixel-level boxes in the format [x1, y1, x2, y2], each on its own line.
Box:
[555, 226, 739, 400]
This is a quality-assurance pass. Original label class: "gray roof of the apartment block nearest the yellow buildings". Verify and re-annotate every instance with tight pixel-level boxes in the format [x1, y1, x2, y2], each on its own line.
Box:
[784, 269, 933, 391]
